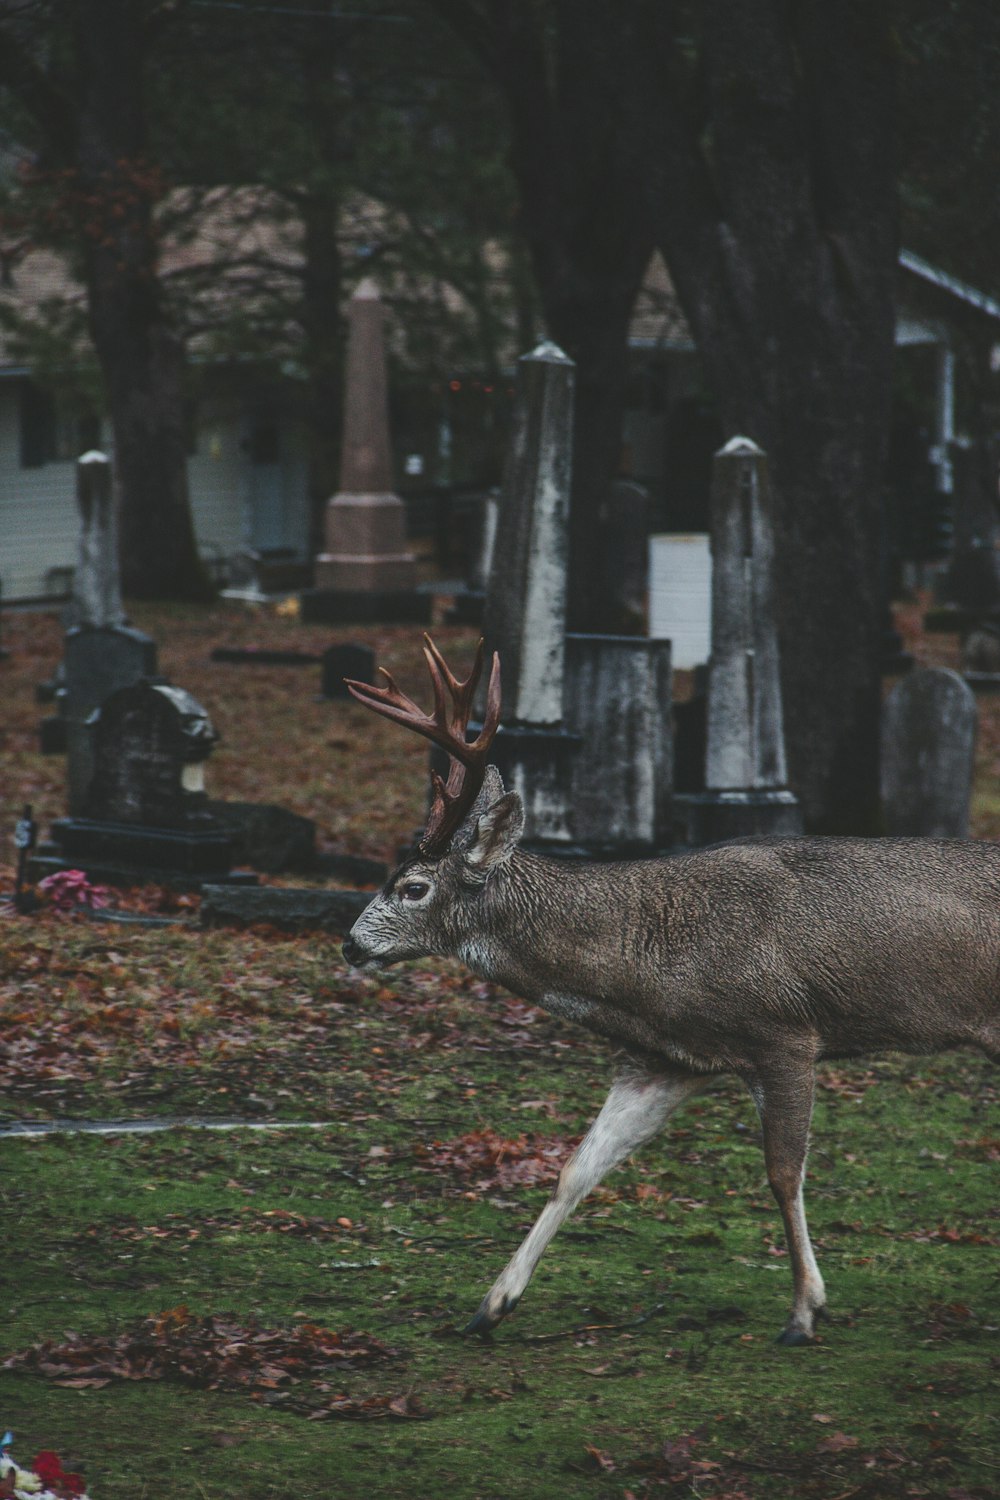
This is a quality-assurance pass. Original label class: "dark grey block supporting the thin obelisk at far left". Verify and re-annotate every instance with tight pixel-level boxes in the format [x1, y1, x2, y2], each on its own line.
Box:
[60, 626, 156, 815]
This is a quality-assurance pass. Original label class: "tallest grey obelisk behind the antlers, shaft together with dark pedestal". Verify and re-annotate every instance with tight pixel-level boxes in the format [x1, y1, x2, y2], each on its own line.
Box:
[484, 342, 579, 843]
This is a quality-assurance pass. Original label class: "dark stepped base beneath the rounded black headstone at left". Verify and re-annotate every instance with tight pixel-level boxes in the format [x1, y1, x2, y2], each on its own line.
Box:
[30, 818, 256, 890]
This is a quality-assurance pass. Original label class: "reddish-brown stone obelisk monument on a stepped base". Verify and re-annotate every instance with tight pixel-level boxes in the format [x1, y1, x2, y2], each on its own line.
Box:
[301, 279, 430, 621]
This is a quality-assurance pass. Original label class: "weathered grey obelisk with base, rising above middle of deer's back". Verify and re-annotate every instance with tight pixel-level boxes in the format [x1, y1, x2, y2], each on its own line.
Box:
[671, 438, 802, 845]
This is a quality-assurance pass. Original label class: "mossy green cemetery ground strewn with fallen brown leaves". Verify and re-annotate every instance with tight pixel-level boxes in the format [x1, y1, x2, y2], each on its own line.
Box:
[0, 606, 1000, 1500]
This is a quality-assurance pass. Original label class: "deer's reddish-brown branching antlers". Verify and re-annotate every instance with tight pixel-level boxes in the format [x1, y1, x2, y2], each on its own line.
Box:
[345, 636, 501, 854]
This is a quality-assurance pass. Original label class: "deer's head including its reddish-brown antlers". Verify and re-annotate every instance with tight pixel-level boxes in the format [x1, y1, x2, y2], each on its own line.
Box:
[343, 636, 525, 968]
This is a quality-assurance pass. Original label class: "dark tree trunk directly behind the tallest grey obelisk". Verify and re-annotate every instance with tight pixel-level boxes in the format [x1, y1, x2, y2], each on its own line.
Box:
[433, 0, 654, 630]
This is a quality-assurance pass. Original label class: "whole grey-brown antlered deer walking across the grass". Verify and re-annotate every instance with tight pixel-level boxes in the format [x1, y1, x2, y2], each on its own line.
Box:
[343, 638, 1000, 1344]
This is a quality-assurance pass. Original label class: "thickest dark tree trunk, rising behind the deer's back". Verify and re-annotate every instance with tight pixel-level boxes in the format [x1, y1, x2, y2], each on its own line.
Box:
[630, 0, 897, 833]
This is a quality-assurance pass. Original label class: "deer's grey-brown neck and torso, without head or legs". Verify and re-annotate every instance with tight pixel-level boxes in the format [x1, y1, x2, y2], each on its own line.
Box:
[449, 839, 1000, 1074]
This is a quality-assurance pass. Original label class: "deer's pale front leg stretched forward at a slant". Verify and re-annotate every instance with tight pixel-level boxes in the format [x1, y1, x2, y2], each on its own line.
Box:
[465, 1068, 708, 1334]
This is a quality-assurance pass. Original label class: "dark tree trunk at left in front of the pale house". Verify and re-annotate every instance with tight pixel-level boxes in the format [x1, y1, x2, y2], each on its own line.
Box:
[73, 0, 213, 599]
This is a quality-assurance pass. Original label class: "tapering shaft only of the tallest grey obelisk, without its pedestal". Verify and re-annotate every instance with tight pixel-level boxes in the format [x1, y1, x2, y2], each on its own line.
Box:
[486, 344, 576, 728]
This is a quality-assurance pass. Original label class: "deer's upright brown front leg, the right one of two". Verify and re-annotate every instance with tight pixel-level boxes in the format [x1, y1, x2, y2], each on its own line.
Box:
[750, 1067, 826, 1344]
